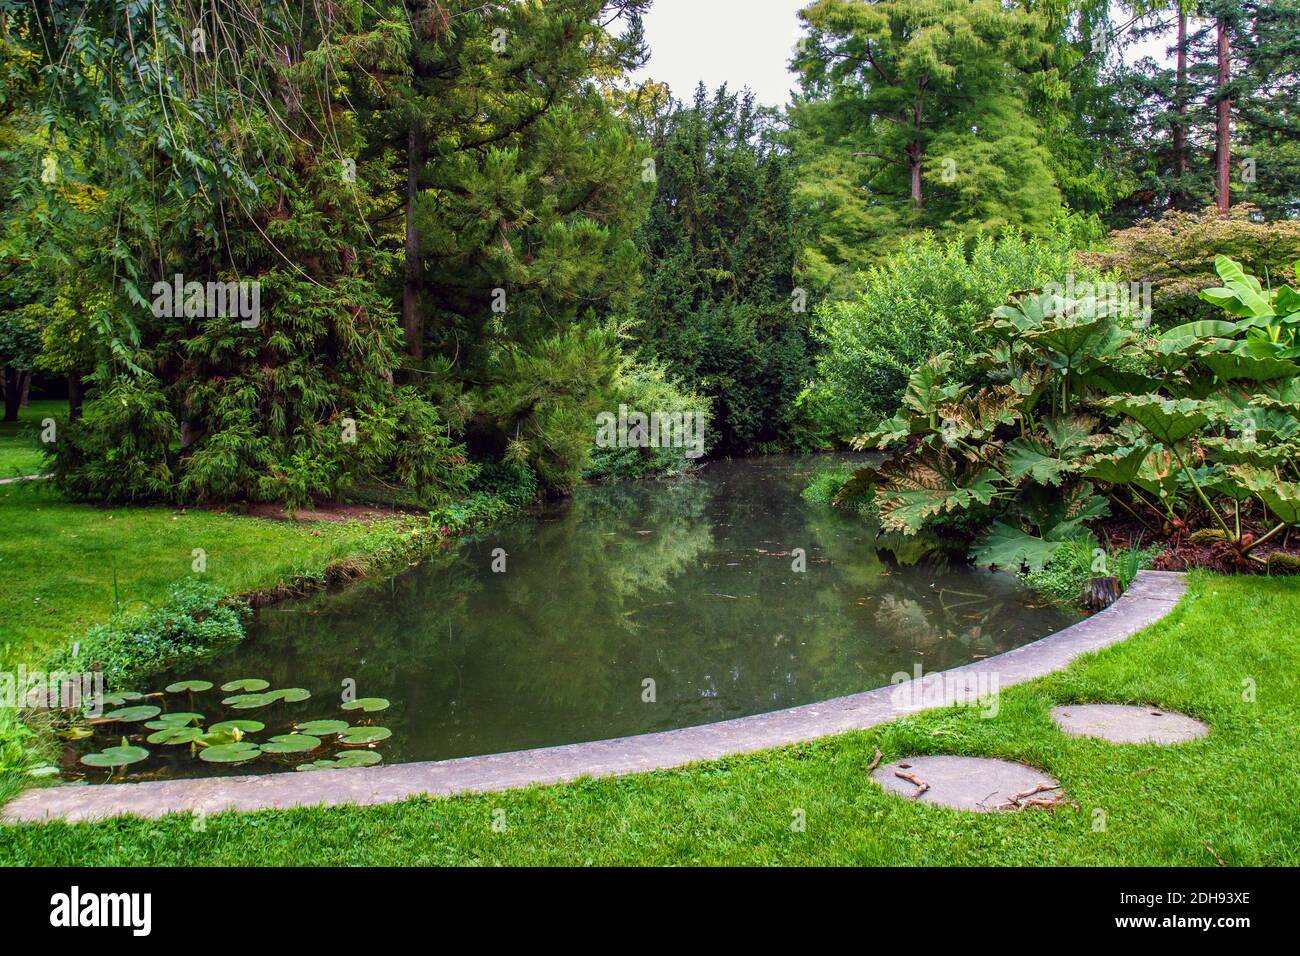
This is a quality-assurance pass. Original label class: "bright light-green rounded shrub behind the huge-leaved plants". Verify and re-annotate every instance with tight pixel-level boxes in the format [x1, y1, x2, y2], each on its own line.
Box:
[811, 230, 1099, 437]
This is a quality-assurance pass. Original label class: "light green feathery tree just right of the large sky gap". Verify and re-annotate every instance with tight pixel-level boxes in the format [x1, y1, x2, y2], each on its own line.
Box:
[793, 0, 1065, 277]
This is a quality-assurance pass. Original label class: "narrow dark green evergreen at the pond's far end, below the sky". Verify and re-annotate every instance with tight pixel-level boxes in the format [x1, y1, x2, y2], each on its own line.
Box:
[638, 85, 810, 451]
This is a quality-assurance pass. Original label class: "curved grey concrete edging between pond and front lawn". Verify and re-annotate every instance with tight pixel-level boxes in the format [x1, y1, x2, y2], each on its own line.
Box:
[0, 571, 1187, 823]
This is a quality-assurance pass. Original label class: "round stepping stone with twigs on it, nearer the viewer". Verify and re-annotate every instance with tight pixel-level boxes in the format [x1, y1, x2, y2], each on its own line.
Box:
[871, 756, 1062, 813]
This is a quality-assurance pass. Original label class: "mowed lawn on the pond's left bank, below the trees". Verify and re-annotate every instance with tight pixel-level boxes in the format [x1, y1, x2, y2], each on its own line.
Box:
[0, 481, 408, 666]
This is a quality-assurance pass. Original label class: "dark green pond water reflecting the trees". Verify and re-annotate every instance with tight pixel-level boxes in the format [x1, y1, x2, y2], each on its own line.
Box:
[73, 457, 1078, 779]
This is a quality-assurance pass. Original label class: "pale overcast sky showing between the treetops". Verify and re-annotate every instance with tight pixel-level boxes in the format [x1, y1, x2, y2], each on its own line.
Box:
[636, 0, 1190, 105]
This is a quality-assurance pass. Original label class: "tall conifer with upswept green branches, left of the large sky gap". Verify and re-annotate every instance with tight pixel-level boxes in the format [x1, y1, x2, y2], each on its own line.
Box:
[348, 0, 654, 490]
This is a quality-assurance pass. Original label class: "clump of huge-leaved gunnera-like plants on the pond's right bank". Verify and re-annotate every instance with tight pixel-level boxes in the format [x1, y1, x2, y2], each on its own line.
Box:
[846, 256, 1300, 568]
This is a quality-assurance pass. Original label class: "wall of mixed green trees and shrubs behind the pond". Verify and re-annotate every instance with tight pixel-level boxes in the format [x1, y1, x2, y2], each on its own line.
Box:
[0, 0, 1300, 523]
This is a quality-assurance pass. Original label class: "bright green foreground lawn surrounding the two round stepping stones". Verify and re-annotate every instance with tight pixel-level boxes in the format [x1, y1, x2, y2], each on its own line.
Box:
[0, 575, 1300, 866]
